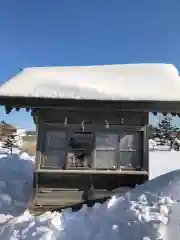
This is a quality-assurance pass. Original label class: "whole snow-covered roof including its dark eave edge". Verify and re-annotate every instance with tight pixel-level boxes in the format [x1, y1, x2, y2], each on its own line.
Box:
[0, 63, 180, 113]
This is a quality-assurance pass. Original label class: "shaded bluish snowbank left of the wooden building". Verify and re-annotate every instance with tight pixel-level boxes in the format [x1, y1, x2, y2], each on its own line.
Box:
[0, 154, 35, 218]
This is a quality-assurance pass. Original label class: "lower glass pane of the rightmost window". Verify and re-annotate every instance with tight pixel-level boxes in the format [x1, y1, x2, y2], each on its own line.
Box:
[119, 151, 142, 169]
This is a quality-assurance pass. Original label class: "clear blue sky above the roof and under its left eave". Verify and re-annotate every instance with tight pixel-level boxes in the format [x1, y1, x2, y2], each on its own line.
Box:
[0, 0, 180, 129]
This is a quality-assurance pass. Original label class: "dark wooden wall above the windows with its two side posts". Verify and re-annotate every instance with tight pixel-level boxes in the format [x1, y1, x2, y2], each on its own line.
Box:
[32, 109, 149, 171]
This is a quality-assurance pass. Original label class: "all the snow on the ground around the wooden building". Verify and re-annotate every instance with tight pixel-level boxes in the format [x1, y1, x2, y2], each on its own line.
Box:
[0, 151, 180, 237]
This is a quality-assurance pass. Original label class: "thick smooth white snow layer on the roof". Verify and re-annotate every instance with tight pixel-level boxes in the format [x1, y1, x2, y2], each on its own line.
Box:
[0, 63, 180, 101]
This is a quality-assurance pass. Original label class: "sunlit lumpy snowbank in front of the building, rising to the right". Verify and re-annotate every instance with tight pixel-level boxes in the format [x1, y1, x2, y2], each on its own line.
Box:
[0, 170, 180, 240]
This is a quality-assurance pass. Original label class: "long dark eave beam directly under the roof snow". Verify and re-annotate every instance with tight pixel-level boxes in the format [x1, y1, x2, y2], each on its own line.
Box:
[0, 96, 180, 113]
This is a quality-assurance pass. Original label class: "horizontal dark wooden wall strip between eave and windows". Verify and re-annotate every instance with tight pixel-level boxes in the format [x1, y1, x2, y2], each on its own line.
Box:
[33, 109, 148, 126]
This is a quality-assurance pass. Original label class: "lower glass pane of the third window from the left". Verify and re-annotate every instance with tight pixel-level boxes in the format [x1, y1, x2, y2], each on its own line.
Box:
[94, 151, 117, 169]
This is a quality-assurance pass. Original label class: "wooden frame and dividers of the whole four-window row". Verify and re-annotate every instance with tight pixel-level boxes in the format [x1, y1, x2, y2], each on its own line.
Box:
[40, 123, 146, 171]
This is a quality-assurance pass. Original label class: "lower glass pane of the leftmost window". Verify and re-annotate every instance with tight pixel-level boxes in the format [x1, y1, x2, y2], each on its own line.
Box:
[43, 150, 66, 169]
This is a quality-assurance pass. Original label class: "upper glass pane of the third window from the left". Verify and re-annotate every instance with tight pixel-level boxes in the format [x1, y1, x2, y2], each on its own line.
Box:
[96, 133, 118, 149]
